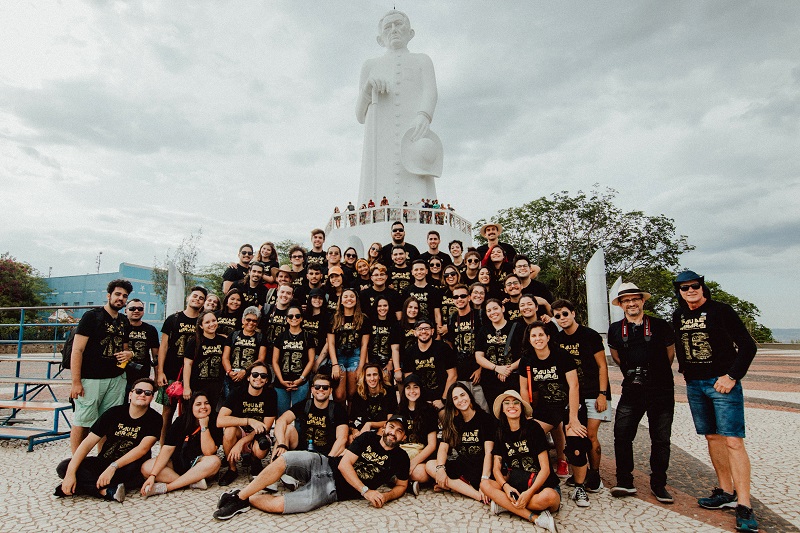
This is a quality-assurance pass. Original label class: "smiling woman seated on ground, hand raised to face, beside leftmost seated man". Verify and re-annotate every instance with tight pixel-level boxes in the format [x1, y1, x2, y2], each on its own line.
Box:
[141, 391, 222, 498]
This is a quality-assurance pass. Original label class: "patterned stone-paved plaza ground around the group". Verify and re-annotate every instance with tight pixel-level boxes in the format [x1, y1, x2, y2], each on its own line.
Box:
[0, 350, 800, 533]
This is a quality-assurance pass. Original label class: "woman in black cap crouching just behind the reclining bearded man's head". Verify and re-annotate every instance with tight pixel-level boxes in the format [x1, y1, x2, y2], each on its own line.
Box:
[397, 374, 439, 496]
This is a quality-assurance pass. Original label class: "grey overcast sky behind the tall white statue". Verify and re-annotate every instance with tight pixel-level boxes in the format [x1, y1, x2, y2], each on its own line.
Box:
[0, 0, 800, 327]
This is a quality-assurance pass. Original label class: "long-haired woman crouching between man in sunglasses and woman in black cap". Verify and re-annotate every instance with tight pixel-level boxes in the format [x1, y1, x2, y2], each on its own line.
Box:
[348, 363, 397, 444]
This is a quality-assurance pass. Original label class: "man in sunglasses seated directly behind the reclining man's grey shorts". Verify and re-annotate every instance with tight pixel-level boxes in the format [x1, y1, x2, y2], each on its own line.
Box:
[273, 374, 349, 459]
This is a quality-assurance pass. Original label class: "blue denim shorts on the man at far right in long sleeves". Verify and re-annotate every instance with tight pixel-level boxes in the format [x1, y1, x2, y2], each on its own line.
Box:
[686, 378, 744, 439]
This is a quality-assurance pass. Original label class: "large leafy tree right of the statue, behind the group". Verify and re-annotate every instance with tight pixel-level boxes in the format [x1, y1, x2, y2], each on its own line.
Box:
[476, 185, 694, 319]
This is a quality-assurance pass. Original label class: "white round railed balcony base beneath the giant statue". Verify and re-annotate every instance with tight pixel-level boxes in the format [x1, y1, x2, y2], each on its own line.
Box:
[325, 206, 473, 257]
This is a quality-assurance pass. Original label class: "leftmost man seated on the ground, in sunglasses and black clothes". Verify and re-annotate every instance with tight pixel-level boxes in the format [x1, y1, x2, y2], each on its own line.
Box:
[54, 378, 161, 503]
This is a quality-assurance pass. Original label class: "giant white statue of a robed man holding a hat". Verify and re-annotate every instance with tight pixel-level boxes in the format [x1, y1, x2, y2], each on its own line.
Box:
[356, 11, 442, 205]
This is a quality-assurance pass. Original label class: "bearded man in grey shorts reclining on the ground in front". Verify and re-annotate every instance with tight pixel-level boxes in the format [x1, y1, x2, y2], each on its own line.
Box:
[214, 417, 409, 520]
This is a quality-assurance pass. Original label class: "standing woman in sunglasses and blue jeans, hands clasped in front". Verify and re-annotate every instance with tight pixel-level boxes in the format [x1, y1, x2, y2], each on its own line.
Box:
[272, 304, 315, 416]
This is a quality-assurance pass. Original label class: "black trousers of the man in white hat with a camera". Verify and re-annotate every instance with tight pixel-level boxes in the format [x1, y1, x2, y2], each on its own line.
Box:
[614, 385, 675, 487]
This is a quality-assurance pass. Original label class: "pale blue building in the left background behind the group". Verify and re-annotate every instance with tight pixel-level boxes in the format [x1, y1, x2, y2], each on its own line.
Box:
[45, 263, 164, 325]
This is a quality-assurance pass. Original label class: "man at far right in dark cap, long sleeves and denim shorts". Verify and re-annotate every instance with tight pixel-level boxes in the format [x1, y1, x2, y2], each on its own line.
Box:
[672, 270, 758, 531]
